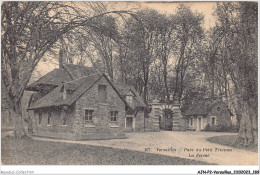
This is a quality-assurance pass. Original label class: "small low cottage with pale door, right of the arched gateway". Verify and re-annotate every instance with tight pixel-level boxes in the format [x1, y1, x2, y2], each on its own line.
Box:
[183, 98, 232, 131]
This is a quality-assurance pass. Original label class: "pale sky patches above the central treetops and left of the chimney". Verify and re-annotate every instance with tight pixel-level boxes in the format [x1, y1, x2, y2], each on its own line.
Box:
[34, 1, 216, 80]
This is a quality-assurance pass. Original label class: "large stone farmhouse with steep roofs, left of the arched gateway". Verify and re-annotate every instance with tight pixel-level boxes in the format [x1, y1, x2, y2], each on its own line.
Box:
[26, 64, 153, 140]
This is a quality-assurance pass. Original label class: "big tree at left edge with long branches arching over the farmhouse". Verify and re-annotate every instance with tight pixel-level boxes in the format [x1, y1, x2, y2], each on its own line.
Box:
[1, 2, 130, 137]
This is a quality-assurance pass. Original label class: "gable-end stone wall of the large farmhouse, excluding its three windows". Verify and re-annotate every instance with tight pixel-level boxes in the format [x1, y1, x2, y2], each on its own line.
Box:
[73, 77, 126, 140]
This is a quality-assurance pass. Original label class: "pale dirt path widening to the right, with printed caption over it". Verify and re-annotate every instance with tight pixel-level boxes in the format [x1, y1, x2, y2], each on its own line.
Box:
[33, 131, 258, 165]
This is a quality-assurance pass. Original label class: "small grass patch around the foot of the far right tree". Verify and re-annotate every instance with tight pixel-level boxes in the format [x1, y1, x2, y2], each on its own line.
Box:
[207, 135, 257, 152]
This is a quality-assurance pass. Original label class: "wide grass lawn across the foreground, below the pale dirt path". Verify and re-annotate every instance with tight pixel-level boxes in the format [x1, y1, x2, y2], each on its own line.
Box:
[1, 137, 211, 165]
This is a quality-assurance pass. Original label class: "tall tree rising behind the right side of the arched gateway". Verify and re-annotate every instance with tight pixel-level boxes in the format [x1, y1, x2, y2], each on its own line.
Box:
[172, 4, 204, 102]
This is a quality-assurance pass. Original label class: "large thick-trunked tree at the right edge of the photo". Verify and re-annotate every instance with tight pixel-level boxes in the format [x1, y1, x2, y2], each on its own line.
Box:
[209, 2, 258, 146]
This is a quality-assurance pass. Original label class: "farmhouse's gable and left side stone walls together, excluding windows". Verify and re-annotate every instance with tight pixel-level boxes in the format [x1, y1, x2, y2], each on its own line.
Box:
[29, 77, 125, 140]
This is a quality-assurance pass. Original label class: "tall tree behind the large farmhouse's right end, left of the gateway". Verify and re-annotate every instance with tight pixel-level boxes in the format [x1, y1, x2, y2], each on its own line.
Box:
[121, 9, 164, 103]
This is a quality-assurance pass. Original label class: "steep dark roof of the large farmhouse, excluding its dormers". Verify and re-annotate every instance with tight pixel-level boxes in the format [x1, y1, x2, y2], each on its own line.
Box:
[26, 64, 146, 109]
